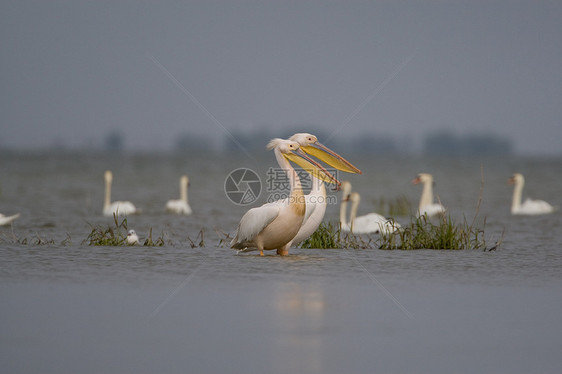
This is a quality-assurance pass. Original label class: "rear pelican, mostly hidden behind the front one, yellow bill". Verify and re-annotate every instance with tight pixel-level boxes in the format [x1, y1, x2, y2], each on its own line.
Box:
[287, 133, 361, 248]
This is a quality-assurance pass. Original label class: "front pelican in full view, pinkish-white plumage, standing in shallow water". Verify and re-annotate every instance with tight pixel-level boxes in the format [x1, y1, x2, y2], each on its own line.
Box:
[230, 139, 339, 256]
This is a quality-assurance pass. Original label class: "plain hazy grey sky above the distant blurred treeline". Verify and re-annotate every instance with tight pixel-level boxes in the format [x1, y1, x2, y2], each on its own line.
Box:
[0, 0, 562, 154]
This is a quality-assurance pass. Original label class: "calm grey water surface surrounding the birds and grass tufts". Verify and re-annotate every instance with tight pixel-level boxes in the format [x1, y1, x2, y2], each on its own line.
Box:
[0, 153, 562, 373]
